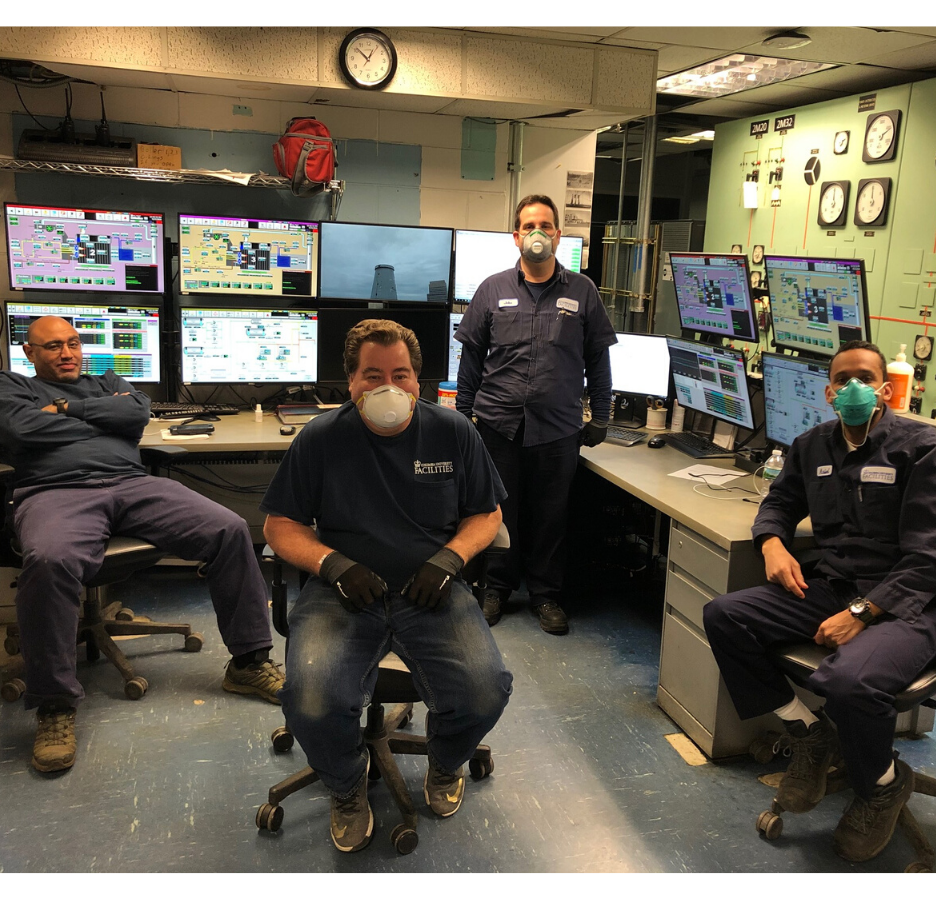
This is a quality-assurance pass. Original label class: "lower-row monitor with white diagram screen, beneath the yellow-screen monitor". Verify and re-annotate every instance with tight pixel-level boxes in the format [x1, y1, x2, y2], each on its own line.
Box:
[180, 309, 318, 384]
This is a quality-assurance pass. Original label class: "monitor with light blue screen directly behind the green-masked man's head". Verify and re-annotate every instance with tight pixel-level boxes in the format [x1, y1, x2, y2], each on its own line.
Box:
[762, 353, 836, 449]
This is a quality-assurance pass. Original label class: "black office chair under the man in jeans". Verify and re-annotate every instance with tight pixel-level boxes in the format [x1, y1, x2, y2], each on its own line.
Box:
[256, 527, 510, 856]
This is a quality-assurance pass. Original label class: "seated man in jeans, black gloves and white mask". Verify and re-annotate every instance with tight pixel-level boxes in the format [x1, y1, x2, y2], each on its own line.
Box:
[261, 320, 513, 853]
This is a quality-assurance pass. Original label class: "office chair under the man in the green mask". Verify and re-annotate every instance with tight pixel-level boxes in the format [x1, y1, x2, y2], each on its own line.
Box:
[757, 643, 936, 875]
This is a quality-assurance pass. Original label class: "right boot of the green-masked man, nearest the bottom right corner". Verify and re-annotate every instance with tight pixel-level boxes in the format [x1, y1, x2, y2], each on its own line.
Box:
[833, 760, 913, 862]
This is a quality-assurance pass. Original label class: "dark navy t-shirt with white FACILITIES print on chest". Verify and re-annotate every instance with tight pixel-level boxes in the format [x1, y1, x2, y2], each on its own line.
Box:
[260, 401, 506, 591]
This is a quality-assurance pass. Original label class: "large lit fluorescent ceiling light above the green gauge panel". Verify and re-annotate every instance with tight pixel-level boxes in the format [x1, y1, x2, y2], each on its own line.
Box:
[657, 53, 836, 99]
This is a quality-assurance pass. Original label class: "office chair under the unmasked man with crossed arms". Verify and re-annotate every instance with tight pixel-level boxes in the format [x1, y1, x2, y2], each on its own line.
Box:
[0, 447, 205, 703]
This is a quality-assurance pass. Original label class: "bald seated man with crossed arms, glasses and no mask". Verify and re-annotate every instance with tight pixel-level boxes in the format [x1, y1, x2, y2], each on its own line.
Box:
[0, 316, 283, 773]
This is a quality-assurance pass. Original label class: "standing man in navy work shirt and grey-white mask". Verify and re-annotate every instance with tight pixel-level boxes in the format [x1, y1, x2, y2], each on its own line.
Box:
[456, 195, 617, 635]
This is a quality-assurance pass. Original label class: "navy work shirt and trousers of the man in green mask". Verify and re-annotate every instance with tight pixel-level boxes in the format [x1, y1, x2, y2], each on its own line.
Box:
[705, 409, 936, 799]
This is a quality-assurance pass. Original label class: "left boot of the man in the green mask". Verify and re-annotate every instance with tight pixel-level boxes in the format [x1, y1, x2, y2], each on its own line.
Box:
[777, 711, 843, 813]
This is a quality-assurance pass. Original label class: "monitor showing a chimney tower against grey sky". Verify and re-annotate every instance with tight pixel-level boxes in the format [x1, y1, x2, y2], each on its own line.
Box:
[319, 222, 453, 306]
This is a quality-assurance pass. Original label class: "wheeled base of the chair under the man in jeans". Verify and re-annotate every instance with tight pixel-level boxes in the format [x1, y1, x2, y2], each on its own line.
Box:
[256, 703, 494, 856]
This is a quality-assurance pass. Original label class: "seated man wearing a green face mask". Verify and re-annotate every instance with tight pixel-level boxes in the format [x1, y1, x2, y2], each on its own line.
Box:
[705, 342, 936, 862]
